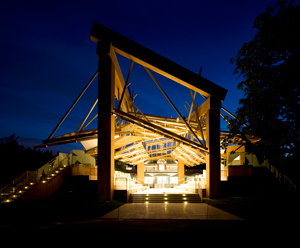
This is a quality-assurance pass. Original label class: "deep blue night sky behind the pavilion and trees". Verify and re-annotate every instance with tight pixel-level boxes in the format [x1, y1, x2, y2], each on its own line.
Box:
[0, 0, 292, 151]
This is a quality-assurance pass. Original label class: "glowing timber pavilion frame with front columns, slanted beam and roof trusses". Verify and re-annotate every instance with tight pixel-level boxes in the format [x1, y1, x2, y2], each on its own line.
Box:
[37, 22, 232, 200]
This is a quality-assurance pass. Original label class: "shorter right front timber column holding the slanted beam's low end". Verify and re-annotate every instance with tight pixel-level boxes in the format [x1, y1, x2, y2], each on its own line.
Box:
[206, 97, 221, 198]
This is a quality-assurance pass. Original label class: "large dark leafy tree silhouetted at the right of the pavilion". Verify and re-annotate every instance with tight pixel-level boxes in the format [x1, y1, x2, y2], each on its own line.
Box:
[223, 0, 300, 176]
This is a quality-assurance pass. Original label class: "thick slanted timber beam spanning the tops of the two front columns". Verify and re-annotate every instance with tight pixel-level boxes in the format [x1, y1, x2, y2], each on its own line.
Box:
[90, 22, 227, 101]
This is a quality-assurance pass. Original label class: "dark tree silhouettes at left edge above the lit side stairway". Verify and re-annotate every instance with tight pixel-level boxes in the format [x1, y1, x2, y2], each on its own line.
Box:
[0, 134, 55, 186]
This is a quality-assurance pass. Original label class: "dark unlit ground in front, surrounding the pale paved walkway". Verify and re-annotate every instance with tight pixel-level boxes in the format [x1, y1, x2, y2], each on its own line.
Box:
[0, 186, 300, 244]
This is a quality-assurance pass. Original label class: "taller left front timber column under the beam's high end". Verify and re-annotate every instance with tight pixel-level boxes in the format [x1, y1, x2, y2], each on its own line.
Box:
[97, 41, 115, 200]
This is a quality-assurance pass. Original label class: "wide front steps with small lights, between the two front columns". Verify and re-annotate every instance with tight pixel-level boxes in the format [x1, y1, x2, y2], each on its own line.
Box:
[128, 194, 202, 203]
